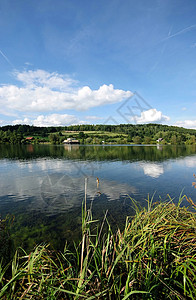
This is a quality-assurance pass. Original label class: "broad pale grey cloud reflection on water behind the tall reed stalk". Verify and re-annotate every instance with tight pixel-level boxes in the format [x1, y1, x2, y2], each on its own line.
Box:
[0, 170, 137, 215]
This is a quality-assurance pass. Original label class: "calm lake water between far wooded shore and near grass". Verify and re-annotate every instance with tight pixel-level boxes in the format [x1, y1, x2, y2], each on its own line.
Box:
[0, 145, 196, 249]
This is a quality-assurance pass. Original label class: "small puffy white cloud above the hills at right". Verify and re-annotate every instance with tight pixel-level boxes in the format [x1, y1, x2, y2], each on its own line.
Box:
[134, 108, 170, 124]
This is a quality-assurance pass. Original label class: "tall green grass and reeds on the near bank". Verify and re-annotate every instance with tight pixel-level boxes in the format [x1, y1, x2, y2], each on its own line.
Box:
[0, 193, 196, 300]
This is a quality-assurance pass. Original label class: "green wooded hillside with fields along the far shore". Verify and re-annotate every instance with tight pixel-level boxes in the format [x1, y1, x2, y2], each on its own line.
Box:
[0, 124, 196, 145]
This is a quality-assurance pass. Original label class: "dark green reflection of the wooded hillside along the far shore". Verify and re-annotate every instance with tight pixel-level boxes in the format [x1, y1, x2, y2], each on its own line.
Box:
[0, 144, 196, 161]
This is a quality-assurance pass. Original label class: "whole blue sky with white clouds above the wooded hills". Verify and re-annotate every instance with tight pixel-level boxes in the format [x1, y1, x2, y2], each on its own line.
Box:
[0, 0, 196, 128]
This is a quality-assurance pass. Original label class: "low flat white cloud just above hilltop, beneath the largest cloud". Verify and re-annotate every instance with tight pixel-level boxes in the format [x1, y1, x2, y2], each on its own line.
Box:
[12, 114, 85, 127]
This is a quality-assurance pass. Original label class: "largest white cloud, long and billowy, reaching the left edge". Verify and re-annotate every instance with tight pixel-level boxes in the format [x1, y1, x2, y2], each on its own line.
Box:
[0, 70, 132, 112]
